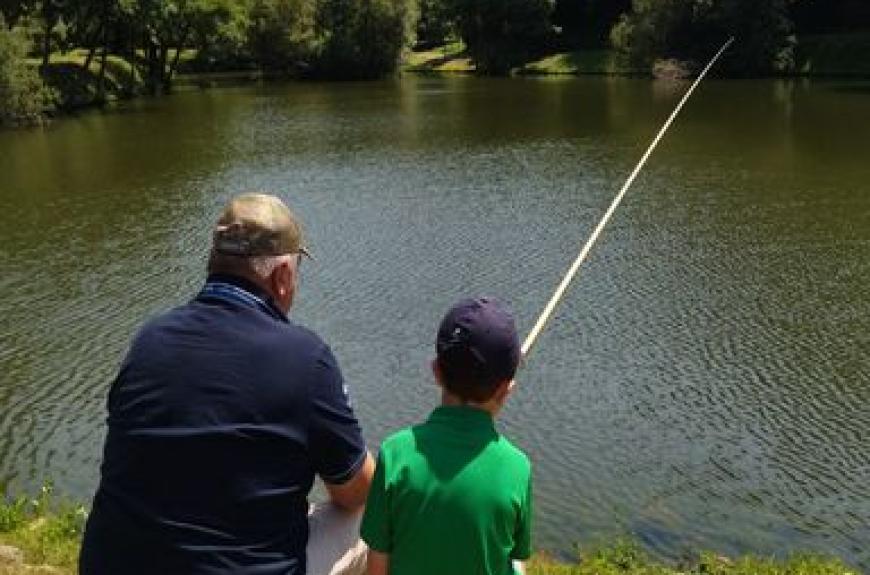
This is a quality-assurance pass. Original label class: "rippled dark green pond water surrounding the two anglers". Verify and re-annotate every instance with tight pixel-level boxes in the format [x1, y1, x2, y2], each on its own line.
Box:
[0, 74, 870, 568]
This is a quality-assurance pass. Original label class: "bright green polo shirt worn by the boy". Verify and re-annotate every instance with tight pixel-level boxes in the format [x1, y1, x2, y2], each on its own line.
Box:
[361, 406, 532, 575]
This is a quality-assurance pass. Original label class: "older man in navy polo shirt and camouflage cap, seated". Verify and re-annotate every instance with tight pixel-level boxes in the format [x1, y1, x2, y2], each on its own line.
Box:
[79, 194, 374, 575]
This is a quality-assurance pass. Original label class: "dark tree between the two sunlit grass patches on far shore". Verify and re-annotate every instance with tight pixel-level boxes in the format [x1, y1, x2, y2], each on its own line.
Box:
[453, 0, 553, 75]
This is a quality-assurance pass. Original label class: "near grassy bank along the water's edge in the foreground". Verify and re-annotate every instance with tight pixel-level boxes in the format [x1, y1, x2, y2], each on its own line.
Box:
[0, 487, 860, 575]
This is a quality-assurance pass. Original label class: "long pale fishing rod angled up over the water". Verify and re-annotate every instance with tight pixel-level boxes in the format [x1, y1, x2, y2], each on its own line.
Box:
[522, 36, 734, 359]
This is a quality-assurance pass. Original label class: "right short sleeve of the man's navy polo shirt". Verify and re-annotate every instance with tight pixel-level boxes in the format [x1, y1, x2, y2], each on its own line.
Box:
[308, 346, 367, 485]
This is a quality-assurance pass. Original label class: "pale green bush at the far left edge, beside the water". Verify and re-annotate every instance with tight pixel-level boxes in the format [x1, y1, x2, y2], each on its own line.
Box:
[0, 15, 51, 125]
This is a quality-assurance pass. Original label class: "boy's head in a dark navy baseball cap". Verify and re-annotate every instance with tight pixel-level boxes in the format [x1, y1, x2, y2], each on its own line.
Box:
[436, 297, 520, 403]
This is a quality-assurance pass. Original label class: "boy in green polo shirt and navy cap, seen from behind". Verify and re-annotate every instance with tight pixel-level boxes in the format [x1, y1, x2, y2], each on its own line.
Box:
[361, 298, 532, 575]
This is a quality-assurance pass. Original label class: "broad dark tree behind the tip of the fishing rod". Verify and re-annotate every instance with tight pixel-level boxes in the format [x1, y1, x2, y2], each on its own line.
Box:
[611, 0, 795, 76]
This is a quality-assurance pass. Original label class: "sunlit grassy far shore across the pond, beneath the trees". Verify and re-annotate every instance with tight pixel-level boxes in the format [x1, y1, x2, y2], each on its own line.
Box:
[13, 34, 870, 130]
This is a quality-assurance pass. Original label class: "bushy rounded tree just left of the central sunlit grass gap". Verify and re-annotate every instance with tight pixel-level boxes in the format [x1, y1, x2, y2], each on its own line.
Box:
[316, 0, 416, 79]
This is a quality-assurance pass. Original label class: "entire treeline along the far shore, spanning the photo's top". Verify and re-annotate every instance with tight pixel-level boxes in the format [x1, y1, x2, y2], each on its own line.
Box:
[0, 0, 870, 122]
